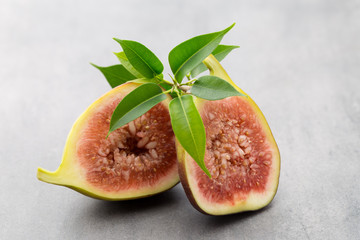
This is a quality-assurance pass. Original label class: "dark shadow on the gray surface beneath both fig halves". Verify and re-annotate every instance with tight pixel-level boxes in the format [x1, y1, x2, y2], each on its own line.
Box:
[83, 185, 272, 227]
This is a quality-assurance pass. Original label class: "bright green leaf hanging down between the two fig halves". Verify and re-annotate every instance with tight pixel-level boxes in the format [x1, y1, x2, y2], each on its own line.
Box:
[169, 95, 211, 178]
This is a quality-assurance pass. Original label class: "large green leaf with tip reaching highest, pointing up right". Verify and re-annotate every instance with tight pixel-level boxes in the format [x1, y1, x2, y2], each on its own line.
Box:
[169, 23, 235, 83]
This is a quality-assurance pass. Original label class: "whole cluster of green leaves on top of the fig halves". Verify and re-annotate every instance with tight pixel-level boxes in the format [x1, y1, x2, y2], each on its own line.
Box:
[92, 24, 243, 177]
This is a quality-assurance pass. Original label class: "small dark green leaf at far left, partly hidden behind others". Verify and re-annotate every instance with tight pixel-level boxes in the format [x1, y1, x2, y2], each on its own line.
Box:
[90, 63, 136, 88]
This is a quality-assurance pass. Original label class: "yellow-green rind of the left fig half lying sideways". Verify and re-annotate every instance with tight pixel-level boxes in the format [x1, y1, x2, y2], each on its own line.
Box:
[37, 82, 179, 201]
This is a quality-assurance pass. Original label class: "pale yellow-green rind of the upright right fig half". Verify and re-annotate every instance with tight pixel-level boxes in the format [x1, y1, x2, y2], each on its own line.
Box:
[176, 55, 280, 215]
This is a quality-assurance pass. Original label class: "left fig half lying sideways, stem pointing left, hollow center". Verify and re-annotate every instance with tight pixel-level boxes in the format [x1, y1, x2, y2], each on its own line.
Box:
[37, 83, 179, 200]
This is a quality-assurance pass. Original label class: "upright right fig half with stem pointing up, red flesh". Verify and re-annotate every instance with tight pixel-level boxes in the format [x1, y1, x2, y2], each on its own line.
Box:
[176, 55, 280, 215]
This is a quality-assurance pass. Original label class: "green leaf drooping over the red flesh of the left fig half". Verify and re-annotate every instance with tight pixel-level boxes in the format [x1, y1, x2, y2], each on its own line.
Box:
[108, 83, 166, 135]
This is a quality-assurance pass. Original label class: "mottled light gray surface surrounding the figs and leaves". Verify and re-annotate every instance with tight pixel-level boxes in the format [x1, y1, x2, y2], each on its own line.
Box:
[0, 0, 360, 239]
